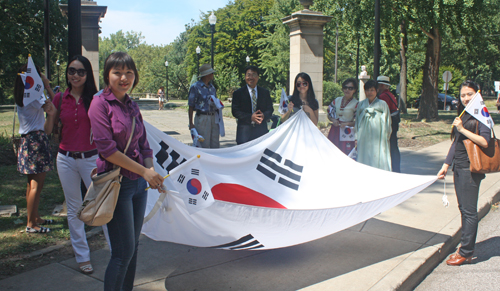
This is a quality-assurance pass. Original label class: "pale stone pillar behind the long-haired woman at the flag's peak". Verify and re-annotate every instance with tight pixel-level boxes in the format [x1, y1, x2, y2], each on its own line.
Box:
[282, 6, 332, 122]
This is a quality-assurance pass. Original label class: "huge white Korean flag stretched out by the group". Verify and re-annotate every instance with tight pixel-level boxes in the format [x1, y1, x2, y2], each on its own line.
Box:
[142, 110, 436, 250]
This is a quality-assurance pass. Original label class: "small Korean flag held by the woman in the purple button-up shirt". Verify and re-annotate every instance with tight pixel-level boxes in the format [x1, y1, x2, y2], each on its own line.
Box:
[170, 155, 214, 214]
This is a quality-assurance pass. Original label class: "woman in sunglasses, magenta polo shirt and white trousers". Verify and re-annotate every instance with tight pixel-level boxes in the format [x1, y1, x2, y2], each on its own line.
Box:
[54, 56, 107, 274]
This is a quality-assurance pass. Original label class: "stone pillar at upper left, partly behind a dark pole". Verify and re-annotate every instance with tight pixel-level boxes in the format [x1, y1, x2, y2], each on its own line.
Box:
[59, 0, 108, 90]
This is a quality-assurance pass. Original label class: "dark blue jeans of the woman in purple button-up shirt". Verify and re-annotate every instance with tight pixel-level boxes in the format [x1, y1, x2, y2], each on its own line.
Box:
[104, 177, 148, 291]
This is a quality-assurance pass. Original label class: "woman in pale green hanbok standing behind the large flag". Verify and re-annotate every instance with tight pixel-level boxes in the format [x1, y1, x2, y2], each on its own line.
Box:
[356, 80, 392, 171]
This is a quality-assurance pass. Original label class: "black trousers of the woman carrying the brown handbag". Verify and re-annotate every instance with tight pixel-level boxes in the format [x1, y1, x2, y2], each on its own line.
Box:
[453, 167, 485, 258]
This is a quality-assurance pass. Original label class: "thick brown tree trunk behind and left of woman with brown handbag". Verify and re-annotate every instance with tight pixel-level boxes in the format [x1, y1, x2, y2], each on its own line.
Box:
[417, 27, 441, 120]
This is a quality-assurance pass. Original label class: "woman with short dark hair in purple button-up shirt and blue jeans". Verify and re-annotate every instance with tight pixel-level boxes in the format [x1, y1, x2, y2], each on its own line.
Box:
[89, 52, 163, 290]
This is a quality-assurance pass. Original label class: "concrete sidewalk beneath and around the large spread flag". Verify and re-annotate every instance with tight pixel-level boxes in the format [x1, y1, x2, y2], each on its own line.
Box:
[0, 106, 500, 291]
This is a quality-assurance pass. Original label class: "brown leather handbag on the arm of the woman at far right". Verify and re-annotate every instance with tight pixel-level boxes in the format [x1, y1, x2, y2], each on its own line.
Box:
[464, 121, 500, 174]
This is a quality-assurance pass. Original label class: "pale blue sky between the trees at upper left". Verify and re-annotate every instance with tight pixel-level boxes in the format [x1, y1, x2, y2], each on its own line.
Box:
[94, 0, 229, 45]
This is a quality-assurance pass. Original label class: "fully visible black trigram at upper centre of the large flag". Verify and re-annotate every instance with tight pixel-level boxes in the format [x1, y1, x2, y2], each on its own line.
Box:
[257, 149, 304, 190]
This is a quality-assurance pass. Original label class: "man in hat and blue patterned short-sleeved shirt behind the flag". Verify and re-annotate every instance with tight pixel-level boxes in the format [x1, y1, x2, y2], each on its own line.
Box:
[188, 64, 222, 148]
